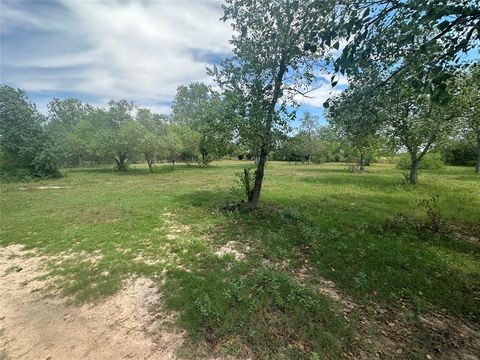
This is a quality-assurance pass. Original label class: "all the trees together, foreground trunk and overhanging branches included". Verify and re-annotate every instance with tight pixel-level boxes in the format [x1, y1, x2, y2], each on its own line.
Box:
[0, 0, 480, 209]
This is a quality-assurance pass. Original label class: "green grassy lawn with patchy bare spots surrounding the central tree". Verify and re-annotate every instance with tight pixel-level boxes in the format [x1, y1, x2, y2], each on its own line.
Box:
[0, 161, 480, 359]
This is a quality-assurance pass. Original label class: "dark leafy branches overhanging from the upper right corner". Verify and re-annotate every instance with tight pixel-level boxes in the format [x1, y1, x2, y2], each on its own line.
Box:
[325, 0, 480, 97]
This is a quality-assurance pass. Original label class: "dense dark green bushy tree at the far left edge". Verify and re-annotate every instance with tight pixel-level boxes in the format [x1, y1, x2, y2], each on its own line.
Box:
[0, 85, 60, 177]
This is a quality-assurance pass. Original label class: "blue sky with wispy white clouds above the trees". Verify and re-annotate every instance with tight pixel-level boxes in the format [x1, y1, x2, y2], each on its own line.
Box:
[0, 0, 346, 126]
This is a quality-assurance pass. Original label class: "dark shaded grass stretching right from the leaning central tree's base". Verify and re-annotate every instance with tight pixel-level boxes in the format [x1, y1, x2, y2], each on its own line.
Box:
[169, 187, 480, 320]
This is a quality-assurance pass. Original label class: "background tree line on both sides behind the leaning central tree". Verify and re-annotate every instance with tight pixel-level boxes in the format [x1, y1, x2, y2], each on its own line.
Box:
[0, 67, 480, 182]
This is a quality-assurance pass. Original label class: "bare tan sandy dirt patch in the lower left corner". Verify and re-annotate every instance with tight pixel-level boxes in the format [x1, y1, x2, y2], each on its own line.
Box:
[0, 246, 183, 360]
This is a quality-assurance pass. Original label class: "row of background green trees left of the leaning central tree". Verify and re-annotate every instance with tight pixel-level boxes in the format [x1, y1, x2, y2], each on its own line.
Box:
[0, 83, 238, 177]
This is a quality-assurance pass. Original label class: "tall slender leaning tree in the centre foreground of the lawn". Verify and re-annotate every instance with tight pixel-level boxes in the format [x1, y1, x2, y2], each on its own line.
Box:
[209, 0, 331, 208]
